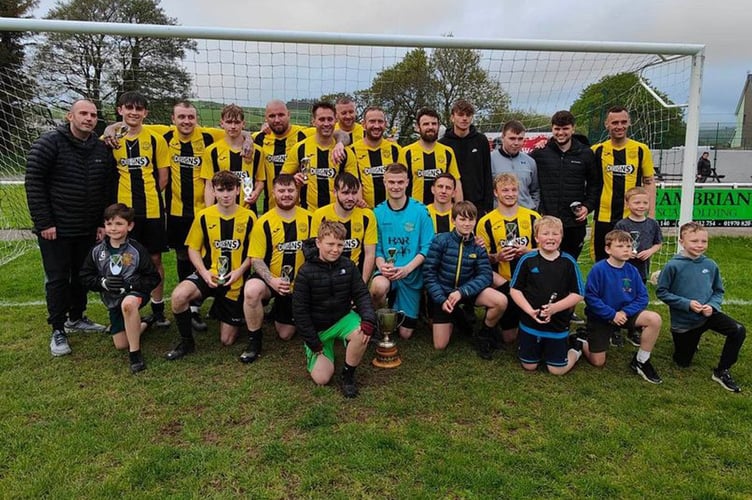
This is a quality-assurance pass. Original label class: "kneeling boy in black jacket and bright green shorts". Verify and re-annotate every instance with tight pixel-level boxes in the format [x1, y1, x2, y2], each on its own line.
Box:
[292, 220, 376, 398]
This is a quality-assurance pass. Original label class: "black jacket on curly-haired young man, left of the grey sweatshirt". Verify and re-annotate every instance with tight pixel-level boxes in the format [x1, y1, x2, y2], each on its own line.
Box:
[439, 125, 494, 213]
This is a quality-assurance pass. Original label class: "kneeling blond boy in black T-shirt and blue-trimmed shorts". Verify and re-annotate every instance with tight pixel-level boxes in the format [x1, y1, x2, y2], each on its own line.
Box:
[509, 215, 585, 375]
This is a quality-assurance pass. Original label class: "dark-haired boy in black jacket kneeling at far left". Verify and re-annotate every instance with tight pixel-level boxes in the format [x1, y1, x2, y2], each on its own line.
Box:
[81, 203, 162, 373]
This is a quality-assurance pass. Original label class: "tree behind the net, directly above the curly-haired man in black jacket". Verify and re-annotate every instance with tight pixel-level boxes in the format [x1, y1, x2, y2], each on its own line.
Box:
[430, 48, 509, 127]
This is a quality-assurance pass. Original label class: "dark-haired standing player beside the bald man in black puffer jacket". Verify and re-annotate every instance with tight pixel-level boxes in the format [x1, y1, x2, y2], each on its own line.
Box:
[112, 91, 170, 327]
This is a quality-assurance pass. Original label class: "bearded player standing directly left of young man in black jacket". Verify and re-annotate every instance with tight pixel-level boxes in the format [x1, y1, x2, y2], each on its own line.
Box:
[400, 108, 462, 205]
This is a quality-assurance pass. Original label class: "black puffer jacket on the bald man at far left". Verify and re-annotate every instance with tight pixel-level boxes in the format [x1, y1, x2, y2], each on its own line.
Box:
[25, 124, 115, 237]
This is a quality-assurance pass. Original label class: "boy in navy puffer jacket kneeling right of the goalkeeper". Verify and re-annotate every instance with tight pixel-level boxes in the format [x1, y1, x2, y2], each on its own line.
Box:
[423, 201, 507, 359]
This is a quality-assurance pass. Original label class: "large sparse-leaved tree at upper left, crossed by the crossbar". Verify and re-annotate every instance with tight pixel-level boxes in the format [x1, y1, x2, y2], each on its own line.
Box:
[34, 0, 196, 126]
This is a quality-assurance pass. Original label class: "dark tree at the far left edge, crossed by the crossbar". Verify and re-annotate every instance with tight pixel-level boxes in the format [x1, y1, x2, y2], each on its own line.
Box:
[0, 0, 37, 153]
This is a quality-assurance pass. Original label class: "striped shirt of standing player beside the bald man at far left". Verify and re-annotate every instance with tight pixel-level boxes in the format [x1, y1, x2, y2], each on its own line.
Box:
[112, 128, 170, 219]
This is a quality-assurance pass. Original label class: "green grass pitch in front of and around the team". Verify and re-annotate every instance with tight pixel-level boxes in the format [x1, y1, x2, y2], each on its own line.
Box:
[0, 238, 752, 499]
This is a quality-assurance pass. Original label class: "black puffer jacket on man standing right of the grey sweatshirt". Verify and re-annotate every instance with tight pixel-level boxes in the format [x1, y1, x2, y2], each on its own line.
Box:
[530, 137, 602, 227]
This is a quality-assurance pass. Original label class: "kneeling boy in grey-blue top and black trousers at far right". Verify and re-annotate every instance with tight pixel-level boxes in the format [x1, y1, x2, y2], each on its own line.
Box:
[655, 222, 747, 392]
